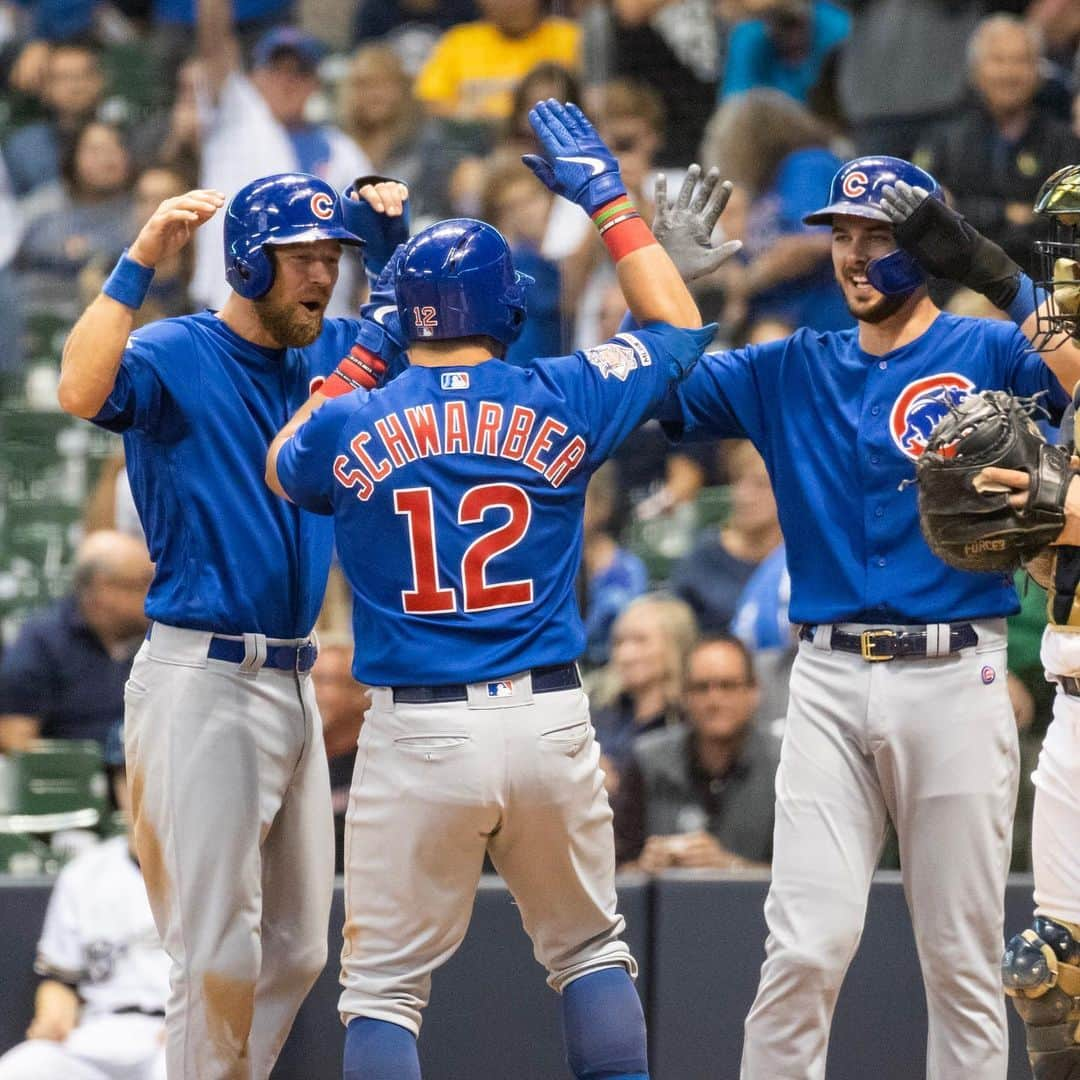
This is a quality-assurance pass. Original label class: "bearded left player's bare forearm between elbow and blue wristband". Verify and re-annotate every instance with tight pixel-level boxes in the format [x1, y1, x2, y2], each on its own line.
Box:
[56, 294, 135, 419]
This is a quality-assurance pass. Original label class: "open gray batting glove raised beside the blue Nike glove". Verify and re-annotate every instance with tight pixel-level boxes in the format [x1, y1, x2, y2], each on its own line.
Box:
[652, 165, 742, 282]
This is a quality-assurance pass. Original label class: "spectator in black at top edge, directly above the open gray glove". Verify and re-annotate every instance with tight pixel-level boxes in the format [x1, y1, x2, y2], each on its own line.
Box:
[609, 0, 719, 165]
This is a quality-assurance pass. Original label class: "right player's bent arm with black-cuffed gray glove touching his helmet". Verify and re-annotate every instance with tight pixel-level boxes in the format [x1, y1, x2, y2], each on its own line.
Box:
[881, 180, 1080, 394]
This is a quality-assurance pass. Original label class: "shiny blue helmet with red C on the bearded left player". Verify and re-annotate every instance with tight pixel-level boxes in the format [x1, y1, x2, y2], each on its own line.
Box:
[225, 173, 364, 300]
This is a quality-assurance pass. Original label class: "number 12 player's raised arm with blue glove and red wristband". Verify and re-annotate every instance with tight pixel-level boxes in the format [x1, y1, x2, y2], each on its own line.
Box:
[522, 99, 701, 327]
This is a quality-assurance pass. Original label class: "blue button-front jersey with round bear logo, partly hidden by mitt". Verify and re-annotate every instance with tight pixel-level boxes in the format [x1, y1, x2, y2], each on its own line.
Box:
[660, 313, 1069, 623]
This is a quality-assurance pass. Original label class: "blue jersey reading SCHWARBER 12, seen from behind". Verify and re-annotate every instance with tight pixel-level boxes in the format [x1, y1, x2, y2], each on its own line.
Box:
[278, 323, 712, 686]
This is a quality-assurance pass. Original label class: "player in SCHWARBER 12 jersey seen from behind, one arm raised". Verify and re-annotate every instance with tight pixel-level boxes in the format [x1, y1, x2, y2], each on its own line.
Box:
[268, 100, 728, 1080]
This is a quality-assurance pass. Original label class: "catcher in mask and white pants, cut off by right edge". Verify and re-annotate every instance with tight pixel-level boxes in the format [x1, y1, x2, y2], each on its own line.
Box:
[954, 165, 1080, 1080]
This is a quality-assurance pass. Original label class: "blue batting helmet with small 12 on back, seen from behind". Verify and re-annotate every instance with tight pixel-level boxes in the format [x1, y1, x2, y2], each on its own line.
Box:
[395, 217, 534, 345]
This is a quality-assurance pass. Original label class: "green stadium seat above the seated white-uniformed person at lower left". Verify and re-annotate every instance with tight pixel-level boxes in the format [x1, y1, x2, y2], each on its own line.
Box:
[0, 739, 108, 834]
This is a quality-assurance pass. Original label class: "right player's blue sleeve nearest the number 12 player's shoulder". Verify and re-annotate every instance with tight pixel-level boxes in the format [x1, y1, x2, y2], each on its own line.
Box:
[657, 341, 785, 446]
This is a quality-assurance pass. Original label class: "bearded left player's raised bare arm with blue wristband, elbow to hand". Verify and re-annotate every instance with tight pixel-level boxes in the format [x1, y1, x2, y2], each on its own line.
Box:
[56, 189, 225, 419]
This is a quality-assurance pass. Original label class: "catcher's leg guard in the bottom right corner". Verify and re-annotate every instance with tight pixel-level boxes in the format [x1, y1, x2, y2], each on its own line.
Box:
[1001, 915, 1080, 1080]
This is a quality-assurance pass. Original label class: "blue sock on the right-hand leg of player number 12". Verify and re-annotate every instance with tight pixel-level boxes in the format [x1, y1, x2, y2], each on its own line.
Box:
[563, 968, 649, 1080]
